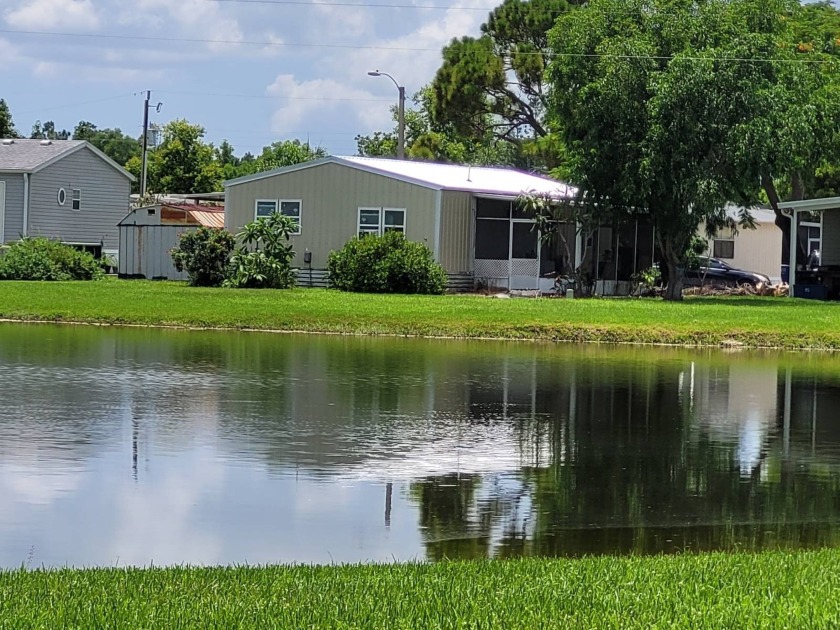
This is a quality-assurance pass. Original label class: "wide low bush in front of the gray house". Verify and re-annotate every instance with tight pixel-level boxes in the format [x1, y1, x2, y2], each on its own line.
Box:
[0, 236, 104, 280]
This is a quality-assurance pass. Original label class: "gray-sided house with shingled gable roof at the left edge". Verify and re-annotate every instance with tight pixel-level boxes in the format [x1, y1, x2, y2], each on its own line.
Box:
[0, 139, 134, 257]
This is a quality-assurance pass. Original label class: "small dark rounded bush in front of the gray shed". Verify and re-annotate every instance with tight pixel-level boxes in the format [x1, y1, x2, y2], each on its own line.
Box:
[170, 226, 236, 287]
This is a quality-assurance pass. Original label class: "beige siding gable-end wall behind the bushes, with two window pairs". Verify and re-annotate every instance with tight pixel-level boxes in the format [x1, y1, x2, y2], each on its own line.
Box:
[225, 164, 436, 269]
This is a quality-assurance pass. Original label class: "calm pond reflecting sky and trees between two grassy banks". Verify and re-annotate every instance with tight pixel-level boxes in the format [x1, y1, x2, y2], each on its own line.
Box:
[0, 324, 840, 567]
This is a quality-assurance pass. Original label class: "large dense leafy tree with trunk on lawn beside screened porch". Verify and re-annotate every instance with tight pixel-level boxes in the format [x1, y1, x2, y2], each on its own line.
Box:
[550, 0, 798, 300]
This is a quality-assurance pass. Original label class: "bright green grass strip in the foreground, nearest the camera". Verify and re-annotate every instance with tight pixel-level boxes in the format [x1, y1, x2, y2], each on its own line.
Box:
[0, 550, 840, 630]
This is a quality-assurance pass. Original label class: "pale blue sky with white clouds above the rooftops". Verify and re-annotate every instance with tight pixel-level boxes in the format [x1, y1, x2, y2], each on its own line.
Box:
[0, 0, 498, 155]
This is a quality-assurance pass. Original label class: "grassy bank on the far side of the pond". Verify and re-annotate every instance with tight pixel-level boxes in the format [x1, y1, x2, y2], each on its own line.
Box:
[0, 280, 840, 349]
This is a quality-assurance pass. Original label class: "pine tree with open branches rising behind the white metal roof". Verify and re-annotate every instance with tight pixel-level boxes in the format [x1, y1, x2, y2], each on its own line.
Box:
[431, 0, 582, 168]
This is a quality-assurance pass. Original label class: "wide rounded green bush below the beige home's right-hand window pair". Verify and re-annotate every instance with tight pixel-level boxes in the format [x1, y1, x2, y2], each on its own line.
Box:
[327, 232, 447, 293]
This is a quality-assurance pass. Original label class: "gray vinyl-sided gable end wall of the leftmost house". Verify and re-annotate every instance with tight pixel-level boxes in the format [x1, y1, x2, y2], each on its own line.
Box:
[29, 148, 131, 249]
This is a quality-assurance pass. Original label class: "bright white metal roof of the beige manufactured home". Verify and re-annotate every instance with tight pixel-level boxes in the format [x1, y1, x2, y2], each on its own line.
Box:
[225, 156, 577, 198]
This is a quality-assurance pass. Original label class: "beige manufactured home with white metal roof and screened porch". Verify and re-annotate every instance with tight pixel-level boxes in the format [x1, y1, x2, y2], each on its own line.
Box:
[225, 157, 592, 289]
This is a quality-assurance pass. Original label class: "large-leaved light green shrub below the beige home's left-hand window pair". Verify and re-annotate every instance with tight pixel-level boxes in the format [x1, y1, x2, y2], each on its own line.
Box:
[225, 213, 297, 289]
